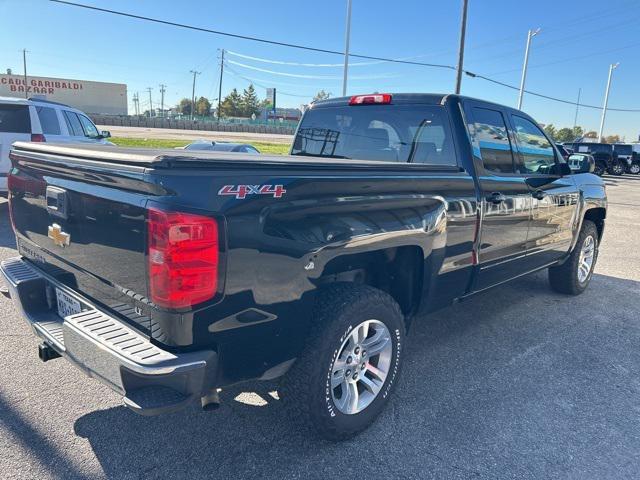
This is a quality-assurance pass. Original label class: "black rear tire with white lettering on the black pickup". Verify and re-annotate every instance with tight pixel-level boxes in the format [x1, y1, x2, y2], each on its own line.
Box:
[281, 283, 405, 441]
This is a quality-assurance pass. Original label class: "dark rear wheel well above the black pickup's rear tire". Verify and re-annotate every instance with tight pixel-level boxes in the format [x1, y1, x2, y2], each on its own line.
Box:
[321, 246, 424, 317]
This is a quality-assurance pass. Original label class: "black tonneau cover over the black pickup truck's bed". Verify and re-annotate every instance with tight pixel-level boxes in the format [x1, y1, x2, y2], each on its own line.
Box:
[11, 142, 460, 172]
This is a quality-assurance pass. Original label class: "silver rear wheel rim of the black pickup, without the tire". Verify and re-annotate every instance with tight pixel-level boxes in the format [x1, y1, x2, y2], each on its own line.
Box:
[331, 320, 393, 415]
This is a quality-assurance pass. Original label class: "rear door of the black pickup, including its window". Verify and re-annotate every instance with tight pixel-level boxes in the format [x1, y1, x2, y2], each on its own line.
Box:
[465, 102, 532, 291]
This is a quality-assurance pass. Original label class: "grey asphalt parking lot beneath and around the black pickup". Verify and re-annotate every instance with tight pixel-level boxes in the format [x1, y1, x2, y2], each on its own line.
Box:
[0, 175, 640, 479]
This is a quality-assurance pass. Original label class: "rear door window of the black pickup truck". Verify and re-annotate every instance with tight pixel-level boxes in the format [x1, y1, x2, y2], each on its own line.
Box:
[473, 107, 514, 173]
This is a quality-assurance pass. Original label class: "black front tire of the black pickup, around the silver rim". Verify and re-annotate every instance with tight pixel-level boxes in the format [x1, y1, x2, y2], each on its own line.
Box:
[549, 220, 599, 295]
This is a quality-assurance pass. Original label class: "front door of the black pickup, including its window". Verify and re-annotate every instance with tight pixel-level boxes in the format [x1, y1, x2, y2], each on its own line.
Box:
[510, 113, 579, 269]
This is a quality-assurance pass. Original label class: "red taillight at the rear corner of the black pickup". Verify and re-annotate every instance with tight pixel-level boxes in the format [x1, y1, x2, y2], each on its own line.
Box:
[147, 209, 219, 309]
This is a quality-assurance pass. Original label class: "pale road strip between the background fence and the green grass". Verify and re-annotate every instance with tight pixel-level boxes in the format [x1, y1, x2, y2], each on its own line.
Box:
[97, 125, 293, 143]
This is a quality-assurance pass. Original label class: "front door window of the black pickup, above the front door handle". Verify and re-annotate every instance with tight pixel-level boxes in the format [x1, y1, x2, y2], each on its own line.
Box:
[512, 115, 556, 173]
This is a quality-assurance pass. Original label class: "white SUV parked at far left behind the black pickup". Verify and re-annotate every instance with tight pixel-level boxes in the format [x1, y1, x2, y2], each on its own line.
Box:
[0, 97, 111, 196]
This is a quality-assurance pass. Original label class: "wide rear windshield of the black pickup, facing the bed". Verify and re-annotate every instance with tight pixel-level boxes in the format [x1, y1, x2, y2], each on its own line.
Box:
[291, 104, 457, 166]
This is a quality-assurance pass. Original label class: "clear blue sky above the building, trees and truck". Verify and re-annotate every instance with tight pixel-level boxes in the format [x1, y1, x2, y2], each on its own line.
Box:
[0, 0, 640, 140]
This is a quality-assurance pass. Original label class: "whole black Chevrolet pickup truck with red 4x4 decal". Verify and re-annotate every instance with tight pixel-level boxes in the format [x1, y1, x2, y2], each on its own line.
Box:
[1, 94, 607, 439]
